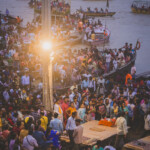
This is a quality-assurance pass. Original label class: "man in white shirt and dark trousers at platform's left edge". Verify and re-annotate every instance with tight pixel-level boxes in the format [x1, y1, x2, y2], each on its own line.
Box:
[66, 111, 77, 147]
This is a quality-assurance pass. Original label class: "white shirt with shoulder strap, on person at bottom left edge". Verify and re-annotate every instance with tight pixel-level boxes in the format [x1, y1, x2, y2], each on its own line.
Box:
[23, 135, 38, 150]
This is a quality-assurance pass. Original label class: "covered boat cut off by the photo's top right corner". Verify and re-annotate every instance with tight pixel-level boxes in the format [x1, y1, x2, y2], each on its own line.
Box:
[131, 1, 150, 14]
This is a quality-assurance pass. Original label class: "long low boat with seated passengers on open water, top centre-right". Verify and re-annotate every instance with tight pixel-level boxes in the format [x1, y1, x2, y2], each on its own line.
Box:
[78, 7, 116, 17]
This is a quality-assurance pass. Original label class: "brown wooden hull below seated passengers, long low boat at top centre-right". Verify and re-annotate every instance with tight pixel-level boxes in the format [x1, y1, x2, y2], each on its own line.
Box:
[79, 12, 116, 17]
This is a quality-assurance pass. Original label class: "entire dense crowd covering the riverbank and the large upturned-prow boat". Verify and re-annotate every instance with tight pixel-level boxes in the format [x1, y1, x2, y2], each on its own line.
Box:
[0, 6, 150, 150]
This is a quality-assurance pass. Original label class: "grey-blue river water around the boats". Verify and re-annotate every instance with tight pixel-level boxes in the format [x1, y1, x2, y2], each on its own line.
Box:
[0, 0, 150, 73]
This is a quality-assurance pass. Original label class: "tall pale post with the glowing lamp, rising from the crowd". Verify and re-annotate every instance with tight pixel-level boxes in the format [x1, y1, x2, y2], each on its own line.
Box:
[42, 0, 53, 111]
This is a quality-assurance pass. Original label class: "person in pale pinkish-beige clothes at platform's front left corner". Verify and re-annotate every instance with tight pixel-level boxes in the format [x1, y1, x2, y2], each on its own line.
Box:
[73, 119, 83, 150]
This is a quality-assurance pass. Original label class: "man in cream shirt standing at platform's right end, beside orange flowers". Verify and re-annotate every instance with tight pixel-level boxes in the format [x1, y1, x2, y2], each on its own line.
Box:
[115, 112, 128, 150]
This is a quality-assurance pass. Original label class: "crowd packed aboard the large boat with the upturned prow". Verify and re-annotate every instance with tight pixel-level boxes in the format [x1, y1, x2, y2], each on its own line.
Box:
[54, 43, 136, 89]
